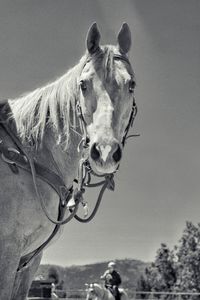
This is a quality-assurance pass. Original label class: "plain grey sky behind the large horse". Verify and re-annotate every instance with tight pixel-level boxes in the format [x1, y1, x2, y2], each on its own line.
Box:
[0, 0, 200, 265]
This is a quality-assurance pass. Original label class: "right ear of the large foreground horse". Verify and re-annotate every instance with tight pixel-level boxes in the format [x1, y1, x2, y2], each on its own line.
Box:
[117, 23, 131, 54]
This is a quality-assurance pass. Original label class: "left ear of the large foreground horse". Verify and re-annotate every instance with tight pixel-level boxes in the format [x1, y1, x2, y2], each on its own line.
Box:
[86, 23, 101, 54]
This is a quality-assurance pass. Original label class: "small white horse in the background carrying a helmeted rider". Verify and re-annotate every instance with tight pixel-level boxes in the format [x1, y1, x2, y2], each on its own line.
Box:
[86, 283, 128, 300]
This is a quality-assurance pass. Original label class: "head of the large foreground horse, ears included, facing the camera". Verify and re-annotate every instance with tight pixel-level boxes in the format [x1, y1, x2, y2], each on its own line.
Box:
[79, 23, 135, 175]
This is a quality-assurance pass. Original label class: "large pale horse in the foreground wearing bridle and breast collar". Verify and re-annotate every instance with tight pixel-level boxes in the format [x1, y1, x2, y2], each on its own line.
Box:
[0, 23, 136, 300]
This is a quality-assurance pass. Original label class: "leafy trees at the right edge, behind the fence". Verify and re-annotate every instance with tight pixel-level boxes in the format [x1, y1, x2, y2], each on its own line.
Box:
[138, 221, 200, 293]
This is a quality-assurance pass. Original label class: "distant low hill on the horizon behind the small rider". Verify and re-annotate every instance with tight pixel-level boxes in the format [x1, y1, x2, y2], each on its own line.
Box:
[37, 259, 148, 291]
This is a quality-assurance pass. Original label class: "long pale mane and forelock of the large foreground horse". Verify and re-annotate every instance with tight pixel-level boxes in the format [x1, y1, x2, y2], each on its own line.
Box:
[10, 46, 125, 148]
